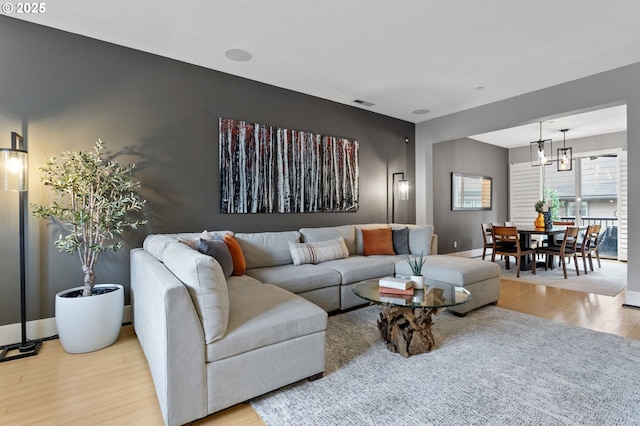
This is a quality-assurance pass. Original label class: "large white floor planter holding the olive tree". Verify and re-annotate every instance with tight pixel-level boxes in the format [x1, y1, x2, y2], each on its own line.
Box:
[56, 284, 124, 354]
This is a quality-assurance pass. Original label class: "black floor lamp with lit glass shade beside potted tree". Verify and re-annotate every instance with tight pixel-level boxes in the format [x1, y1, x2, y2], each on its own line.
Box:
[0, 132, 42, 362]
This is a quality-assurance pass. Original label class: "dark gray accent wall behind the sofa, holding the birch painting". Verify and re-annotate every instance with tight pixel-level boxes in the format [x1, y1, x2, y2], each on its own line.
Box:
[0, 16, 415, 325]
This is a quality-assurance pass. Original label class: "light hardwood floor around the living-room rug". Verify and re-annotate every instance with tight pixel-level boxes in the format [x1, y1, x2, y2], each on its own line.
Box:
[0, 280, 640, 426]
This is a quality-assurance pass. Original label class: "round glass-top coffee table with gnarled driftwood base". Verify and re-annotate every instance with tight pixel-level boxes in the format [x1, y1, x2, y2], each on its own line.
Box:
[353, 279, 471, 358]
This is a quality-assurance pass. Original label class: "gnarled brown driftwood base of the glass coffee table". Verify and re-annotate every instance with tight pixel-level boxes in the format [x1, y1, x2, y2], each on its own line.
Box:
[378, 305, 438, 358]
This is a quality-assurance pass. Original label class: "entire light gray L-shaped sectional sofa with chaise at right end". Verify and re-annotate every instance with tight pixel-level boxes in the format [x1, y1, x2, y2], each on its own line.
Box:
[131, 224, 500, 425]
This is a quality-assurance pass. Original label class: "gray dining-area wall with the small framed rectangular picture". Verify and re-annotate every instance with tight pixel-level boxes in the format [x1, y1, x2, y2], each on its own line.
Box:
[433, 138, 509, 253]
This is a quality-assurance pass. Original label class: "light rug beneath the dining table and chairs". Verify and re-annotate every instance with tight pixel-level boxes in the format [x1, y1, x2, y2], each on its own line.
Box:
[496, 258, 627, 296]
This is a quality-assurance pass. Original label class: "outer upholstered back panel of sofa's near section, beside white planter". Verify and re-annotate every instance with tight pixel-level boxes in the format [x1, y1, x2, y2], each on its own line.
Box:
[131, 249, 208, 425]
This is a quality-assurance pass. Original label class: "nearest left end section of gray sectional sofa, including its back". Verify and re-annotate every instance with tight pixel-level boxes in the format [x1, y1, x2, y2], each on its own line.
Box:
[131, 243, 327, 425]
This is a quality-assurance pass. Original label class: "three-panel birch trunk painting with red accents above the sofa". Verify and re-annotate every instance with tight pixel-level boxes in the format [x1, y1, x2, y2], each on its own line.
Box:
[219, 118, 359, 213]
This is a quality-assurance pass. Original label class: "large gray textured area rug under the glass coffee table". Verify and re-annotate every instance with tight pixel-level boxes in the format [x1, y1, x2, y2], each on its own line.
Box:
[251, 306, 640, 425]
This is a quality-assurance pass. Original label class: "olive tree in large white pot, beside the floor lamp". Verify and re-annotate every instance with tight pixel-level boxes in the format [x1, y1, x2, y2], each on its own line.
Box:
[32, 140, 146, 353]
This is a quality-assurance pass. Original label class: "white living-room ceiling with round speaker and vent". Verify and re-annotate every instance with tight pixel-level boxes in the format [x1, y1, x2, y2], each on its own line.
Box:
[6, 0, 640, 124]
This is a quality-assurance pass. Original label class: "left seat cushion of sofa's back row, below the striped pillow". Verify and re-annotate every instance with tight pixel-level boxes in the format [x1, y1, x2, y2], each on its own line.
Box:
[247, 261, 342, 293]
